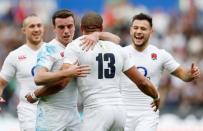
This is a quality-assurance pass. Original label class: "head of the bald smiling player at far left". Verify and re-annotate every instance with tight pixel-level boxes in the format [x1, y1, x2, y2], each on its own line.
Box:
[22, 16, 44, 45]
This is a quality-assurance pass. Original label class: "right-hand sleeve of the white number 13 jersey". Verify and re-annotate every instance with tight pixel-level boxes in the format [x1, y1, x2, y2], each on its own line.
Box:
[121, 48, 134, 72]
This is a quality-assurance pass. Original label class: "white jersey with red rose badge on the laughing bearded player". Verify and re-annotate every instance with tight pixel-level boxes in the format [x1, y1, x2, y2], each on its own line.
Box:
[120, 45, 179, 111]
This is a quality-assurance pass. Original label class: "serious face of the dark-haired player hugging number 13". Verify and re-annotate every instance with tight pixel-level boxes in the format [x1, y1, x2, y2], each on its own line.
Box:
[54, 16, 75, 46]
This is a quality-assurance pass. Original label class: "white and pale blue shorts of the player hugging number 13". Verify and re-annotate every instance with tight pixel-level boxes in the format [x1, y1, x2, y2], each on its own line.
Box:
[36, 104, 81, 131]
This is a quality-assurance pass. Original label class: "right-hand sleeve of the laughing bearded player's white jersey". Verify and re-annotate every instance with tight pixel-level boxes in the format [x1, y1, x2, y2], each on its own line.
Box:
[163, 50, 180, 73]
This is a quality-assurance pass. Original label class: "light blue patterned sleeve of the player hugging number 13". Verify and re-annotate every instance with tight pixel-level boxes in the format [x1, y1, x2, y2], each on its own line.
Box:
[36, 46, 57, 70]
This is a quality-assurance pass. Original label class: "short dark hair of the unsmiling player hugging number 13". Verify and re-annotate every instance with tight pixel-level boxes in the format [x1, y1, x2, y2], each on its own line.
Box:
[52, 9, 75, 26]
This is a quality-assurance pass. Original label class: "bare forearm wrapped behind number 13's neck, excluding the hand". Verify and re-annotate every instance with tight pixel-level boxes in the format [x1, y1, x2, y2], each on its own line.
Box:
[99, 32, 121, 44]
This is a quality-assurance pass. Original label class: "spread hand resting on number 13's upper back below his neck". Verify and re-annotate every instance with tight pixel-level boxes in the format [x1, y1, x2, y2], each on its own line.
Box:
[80, 32, 99, 51]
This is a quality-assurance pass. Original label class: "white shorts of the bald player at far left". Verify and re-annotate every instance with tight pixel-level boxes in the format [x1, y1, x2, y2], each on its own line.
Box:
[17, 103, 37, 131]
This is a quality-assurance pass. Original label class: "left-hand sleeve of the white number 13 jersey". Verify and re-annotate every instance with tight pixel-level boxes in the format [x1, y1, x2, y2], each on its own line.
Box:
[63, 41, 81, 64]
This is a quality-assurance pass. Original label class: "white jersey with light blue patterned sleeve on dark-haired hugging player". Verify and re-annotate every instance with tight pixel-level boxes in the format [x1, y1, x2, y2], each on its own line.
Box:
[37, 39, 78, 109]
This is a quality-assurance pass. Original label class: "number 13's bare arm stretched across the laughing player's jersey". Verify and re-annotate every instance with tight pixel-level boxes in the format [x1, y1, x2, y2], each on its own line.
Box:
[124, 66, 160, 111]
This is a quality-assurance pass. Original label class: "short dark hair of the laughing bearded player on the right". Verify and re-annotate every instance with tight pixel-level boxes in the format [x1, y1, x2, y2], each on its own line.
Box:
[132, 13, 153, 27]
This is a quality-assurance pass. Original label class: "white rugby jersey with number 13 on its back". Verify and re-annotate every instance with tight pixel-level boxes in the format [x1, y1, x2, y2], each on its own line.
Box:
[64, 37, 133, 108]
